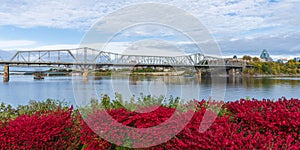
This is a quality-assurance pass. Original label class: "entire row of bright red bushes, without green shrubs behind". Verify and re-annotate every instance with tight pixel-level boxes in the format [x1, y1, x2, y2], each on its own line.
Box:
[0, 98, 300, 150]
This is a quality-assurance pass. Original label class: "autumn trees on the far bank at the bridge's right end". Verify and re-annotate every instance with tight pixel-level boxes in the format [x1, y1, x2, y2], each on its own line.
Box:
[243, 60, 300, 75]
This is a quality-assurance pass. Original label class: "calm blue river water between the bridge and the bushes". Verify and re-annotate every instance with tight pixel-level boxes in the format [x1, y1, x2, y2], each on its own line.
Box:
[0, 75, 300, 106]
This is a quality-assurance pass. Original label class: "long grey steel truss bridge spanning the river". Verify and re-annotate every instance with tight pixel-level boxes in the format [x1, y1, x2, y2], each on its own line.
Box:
[0, 47, 247, 70]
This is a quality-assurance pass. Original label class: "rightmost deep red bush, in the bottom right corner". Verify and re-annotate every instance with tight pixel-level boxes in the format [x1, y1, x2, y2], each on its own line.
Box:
[226, 98, 300, 149]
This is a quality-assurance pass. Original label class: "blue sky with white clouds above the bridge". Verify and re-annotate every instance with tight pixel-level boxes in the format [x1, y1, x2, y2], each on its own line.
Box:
[0, 0, 300, 58]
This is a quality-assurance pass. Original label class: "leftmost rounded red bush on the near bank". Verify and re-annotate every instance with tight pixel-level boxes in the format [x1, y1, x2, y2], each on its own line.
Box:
[0, 107, 80, 149]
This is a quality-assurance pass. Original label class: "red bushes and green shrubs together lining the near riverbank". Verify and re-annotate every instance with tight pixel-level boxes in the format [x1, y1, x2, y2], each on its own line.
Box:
[0, 94, 300, 150]
